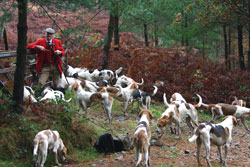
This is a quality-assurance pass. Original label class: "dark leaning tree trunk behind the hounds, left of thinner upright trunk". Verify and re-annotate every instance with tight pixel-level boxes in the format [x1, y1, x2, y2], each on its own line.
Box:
[101, 14, 115, 69]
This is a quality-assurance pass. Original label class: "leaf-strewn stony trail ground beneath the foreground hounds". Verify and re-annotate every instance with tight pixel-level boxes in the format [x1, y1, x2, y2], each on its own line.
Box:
[63, 108, 250, 167]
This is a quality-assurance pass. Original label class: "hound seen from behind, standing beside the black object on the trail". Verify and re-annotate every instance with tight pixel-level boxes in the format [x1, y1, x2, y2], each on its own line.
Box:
[133, 110, 153, 166]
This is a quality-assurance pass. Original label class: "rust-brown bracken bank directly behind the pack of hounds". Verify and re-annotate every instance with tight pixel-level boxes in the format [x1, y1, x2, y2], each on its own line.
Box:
[69, 33, 250, 103]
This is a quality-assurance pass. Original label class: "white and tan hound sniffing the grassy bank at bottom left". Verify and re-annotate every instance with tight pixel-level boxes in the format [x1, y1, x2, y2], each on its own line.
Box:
[33, 129, 67, 167]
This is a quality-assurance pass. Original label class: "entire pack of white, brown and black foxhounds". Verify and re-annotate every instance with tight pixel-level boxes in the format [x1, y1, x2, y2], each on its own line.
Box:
[24, 65, 250, 167]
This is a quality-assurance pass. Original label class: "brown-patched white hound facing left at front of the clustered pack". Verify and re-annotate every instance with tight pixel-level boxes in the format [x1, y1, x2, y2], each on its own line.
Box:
[72, 82, 117, 124]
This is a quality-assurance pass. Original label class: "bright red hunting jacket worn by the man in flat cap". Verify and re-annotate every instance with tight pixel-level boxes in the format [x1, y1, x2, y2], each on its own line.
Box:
[26, 38, 65, 74]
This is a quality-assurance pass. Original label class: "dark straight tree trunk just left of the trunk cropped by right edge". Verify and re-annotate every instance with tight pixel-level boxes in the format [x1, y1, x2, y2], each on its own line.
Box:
[237, 24, 245, 70]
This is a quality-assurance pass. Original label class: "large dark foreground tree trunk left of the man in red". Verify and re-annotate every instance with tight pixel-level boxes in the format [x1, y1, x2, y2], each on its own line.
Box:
[13, 0, 28, 113]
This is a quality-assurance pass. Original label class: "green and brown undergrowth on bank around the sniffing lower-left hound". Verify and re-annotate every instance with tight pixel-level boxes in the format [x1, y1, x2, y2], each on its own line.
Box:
[0, 92, 99, 167]
